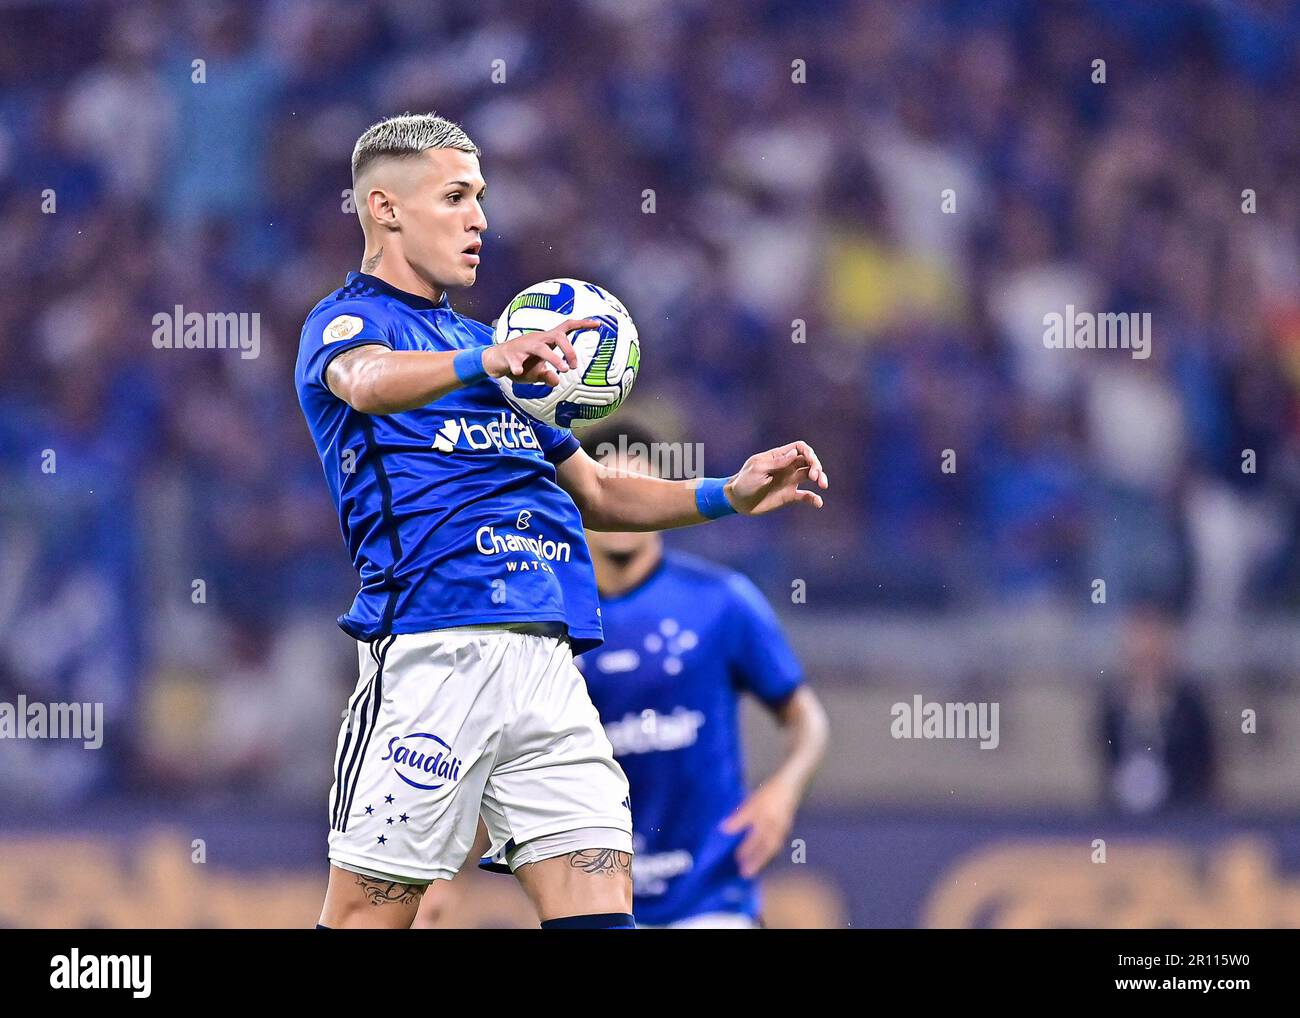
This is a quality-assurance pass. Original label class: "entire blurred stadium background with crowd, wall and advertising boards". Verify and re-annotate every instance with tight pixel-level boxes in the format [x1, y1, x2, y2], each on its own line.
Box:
[0, 0, 1300, 926]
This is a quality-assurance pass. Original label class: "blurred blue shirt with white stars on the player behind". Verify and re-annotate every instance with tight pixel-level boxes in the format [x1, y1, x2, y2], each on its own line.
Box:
[581, 553, 801, 926]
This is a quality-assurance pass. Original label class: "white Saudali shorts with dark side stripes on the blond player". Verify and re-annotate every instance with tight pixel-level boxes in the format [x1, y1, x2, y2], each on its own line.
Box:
[329, 624, 632, 884]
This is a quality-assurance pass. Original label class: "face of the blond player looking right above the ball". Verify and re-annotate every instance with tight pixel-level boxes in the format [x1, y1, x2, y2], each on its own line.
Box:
[400, 148, 488, 289]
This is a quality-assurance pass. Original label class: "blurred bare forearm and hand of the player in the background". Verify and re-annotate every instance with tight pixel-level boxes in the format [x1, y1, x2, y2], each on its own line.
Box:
[723, 685, 831, 876]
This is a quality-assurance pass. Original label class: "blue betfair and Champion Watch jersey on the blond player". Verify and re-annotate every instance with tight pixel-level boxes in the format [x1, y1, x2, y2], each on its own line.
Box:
[295, 272, 601, 653]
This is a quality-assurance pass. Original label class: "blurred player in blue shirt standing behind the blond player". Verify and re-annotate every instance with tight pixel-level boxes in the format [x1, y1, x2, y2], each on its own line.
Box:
[572, 424, 828, 928]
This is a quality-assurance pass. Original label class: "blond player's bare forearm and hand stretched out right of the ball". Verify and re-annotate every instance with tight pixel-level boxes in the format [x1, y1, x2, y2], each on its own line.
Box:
[556, 442, 828, 530]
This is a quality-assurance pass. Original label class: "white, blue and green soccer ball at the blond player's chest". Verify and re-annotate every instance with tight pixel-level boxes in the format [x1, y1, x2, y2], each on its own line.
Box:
[493, 280, 641, 429]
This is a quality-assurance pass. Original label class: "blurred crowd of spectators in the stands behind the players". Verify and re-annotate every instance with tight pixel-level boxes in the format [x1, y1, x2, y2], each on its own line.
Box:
[0, 0, 1300, 801]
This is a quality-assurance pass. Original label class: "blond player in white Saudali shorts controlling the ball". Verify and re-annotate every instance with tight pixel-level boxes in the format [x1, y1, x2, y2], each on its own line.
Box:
[295, 114, 827, 928]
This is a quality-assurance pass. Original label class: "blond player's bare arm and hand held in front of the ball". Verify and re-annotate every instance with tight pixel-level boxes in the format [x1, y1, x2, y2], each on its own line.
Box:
[325, 319, 599, 415]
